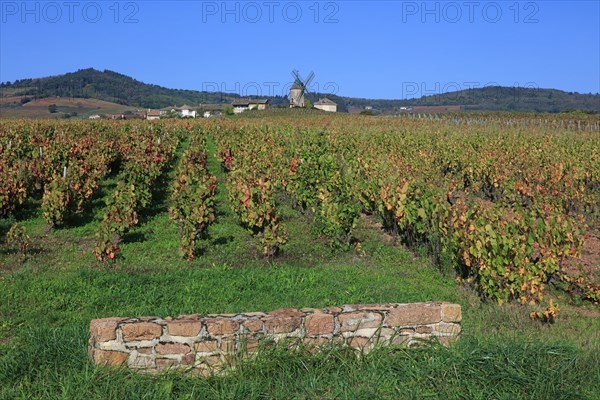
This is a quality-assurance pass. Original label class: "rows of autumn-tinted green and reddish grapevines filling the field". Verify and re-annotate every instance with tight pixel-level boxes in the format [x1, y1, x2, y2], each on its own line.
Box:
[0, 117, 600, 310]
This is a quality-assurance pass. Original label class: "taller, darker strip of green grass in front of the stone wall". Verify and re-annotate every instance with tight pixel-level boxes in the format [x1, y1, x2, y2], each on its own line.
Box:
[0, 328, 600, 399]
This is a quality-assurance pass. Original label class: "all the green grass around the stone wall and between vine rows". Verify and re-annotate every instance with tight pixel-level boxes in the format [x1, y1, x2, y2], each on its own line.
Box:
[0, 137, 600, 399]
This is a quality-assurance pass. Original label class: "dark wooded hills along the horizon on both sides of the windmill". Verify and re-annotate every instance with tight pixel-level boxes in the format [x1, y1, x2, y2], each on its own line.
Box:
[0, 68, 600, 113]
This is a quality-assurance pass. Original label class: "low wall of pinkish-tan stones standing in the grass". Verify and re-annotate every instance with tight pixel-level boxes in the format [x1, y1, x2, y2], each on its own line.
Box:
[89, 303, 461, 374]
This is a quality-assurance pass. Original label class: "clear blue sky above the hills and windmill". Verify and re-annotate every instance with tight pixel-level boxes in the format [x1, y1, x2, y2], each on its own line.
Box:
[0, 0, 600, 99]
